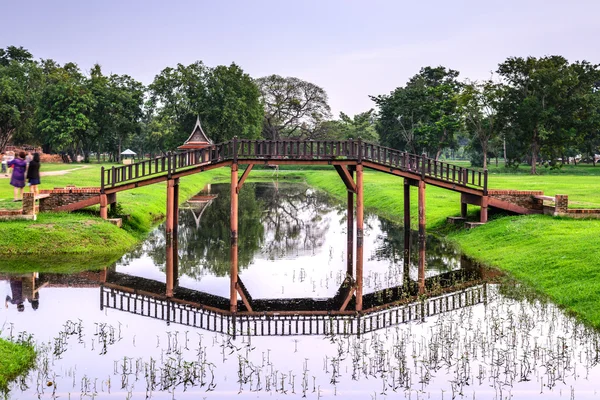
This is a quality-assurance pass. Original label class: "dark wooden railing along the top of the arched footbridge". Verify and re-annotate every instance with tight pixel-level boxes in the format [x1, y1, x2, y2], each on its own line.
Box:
[100, 138, 487, 193]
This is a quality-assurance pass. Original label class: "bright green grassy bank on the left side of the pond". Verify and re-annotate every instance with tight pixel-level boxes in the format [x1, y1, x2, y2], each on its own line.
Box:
[0, 165, 227, 255]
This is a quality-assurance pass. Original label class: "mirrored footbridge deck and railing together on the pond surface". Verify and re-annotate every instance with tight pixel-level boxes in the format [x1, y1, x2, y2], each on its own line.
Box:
[100, 253, 489, 336]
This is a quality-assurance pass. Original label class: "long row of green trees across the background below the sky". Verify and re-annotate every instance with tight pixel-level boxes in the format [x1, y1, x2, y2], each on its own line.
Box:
[0, 46, 600, 173]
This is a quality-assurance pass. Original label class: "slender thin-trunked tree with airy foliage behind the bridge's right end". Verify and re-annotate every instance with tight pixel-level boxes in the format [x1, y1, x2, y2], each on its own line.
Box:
[458, 80, 502, 169]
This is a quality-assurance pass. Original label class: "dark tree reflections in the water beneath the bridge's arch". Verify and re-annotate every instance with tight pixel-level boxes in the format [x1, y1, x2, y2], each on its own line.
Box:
[134, 183, 341, 279]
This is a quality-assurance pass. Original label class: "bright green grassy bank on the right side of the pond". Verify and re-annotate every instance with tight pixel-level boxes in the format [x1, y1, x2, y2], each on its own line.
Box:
[305, 168, 600, 328]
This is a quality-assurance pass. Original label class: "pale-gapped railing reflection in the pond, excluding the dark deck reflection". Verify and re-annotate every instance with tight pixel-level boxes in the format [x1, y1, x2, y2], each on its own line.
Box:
[100, 284, 487, 336]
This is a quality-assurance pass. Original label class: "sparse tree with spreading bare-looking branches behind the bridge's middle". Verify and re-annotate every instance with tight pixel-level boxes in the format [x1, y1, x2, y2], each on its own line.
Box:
[256, 75, 331, 140]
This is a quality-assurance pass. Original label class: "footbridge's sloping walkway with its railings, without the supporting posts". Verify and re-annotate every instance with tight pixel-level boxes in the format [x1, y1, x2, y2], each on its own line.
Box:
[101, 139, 487, 196]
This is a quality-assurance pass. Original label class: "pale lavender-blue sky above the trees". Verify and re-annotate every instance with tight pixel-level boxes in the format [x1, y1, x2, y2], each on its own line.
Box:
[0, 0, 600, 116]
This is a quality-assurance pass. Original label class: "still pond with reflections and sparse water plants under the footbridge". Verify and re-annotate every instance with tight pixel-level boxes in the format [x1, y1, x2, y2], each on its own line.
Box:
[0, 182, 600, 399]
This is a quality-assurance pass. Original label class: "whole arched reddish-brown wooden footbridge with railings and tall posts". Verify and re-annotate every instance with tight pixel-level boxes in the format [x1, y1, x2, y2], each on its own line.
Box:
[92, 138, 527, 313]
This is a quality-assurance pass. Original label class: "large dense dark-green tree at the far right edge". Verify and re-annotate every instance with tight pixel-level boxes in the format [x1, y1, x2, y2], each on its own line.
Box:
[498, 56, 598, 174]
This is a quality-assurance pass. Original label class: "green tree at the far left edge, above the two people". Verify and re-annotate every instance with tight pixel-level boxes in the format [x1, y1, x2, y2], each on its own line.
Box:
[0, 46, 41, 151]
